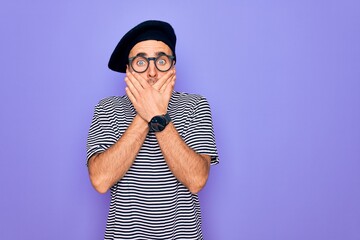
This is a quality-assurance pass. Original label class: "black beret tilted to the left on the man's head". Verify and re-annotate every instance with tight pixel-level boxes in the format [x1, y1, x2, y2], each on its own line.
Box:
[108, 20, 176, 73]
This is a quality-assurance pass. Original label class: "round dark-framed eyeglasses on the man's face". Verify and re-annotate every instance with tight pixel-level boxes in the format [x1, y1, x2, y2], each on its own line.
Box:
[129, 54, 174, 73]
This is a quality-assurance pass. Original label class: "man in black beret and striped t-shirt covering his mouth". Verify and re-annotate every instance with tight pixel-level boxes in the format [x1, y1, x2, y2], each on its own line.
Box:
[87, 21, 219, 240]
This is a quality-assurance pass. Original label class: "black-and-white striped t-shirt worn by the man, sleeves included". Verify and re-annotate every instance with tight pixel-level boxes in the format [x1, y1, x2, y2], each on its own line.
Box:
[87, 91, 219, 240]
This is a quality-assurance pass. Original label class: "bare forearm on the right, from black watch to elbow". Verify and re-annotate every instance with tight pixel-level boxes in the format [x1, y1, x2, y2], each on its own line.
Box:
[156, 123, 210, 194]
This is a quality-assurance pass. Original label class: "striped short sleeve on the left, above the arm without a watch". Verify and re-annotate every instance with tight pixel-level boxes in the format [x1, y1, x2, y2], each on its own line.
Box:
[86, 104, 117, 165]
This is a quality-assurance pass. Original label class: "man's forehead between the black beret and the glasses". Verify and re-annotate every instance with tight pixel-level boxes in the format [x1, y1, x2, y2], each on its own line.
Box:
[129, 40, 171, 57]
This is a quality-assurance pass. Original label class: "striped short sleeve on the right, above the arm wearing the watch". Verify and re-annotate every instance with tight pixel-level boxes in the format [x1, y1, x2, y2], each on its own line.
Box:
[183, 97, 219, 165]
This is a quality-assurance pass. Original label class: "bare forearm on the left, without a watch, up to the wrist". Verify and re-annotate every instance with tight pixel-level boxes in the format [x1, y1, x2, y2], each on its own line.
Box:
[89, 115, 148, 193]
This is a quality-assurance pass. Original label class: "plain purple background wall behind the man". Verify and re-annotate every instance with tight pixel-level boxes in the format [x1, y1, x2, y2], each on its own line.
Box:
[0, 0, 360, 240]
